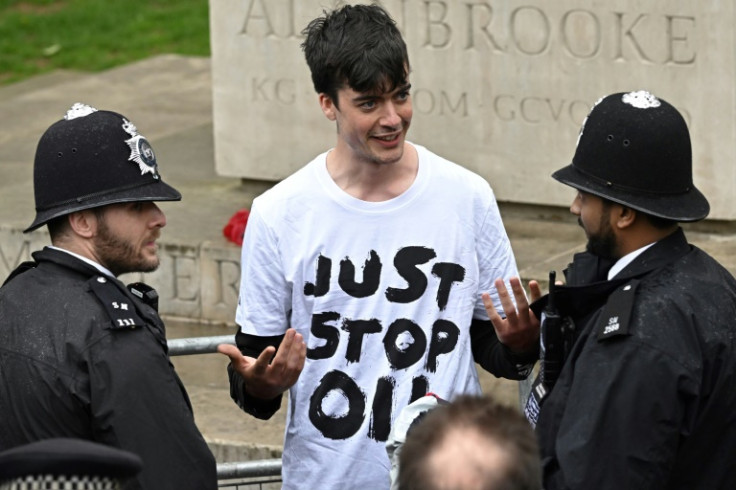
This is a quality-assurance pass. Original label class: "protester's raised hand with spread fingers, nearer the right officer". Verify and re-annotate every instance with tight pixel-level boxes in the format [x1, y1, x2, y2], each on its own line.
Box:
[481, 277, 542, 353]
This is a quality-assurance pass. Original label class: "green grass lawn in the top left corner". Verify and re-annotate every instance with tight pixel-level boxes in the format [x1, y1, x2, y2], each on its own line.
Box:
[0, 0, 210, 84]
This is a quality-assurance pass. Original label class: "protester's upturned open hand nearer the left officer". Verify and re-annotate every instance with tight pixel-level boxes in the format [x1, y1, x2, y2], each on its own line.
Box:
[217, 328, 307, 400]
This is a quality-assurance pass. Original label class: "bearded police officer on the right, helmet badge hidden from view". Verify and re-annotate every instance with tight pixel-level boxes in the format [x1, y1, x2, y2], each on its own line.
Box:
[492, 91, 736, 490]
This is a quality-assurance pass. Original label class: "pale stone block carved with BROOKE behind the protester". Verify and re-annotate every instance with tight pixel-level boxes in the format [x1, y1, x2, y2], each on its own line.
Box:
[210, 0, 736, 220]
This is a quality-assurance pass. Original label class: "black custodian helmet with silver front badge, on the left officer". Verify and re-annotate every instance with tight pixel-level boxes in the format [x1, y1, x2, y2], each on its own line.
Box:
[25, 103, 181, 232]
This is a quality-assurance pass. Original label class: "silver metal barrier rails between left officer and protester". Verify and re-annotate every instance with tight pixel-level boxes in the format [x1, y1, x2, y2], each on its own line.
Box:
[167, 335, 281, 490]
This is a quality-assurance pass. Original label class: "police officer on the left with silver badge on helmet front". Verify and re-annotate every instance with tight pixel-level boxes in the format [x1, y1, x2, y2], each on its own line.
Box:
[0, 104, 217, 490]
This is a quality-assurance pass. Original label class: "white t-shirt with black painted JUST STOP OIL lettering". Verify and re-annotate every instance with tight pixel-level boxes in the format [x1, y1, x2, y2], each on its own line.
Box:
[236, 145, 518, 490]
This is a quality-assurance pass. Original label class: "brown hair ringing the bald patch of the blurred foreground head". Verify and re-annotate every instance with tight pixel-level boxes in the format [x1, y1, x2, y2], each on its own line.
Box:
[397, 395, 542, 490]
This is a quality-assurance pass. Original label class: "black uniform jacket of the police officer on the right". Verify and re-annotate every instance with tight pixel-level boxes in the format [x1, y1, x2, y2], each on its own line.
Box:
[537, 230, 736, 490]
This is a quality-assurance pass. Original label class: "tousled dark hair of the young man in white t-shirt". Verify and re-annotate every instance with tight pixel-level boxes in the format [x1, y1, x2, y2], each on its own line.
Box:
[302, 5, 409, 106]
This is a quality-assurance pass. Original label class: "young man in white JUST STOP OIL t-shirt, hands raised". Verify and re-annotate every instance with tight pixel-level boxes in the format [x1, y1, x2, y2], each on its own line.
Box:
[220, 5, 538, 489]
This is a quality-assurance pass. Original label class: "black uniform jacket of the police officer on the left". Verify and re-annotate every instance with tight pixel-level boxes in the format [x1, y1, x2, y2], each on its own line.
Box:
[0, 248, 217, 490]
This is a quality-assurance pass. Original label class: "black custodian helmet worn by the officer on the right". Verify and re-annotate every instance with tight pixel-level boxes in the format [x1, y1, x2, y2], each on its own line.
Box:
[552, 90, 710, 221]
